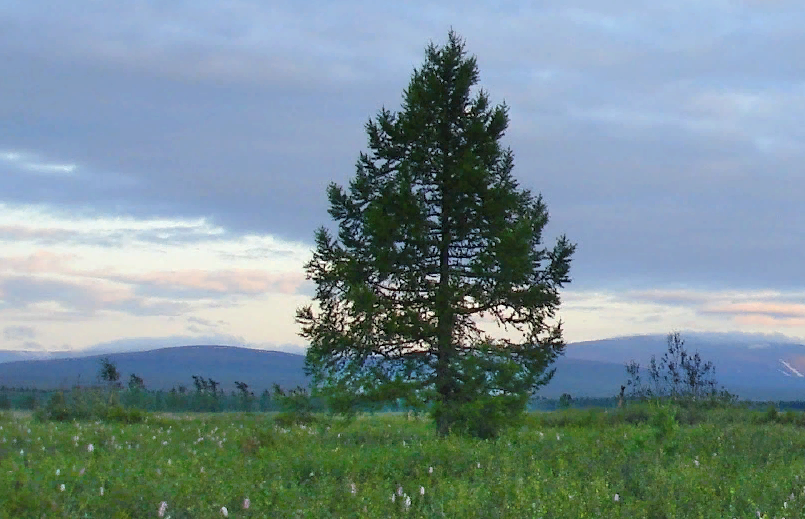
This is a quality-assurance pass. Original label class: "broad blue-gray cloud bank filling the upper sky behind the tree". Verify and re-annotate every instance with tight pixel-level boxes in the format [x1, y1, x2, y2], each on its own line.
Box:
[0, 0, 805, 288]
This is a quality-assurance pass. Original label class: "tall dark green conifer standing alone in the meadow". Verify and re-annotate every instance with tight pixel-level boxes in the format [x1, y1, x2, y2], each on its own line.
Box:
[296, 31, 575, 436]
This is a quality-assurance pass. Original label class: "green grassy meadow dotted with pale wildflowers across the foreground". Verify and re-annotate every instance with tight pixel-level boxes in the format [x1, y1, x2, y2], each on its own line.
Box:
[0, 408, 805, 519]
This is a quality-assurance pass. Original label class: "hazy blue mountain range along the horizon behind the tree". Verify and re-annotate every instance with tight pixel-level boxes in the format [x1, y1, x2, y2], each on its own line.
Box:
[0, 333, 805, 400]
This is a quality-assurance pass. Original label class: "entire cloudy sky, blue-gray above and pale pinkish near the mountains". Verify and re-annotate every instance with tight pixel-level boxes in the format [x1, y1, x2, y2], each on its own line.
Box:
[0, 0, 805, 351]
